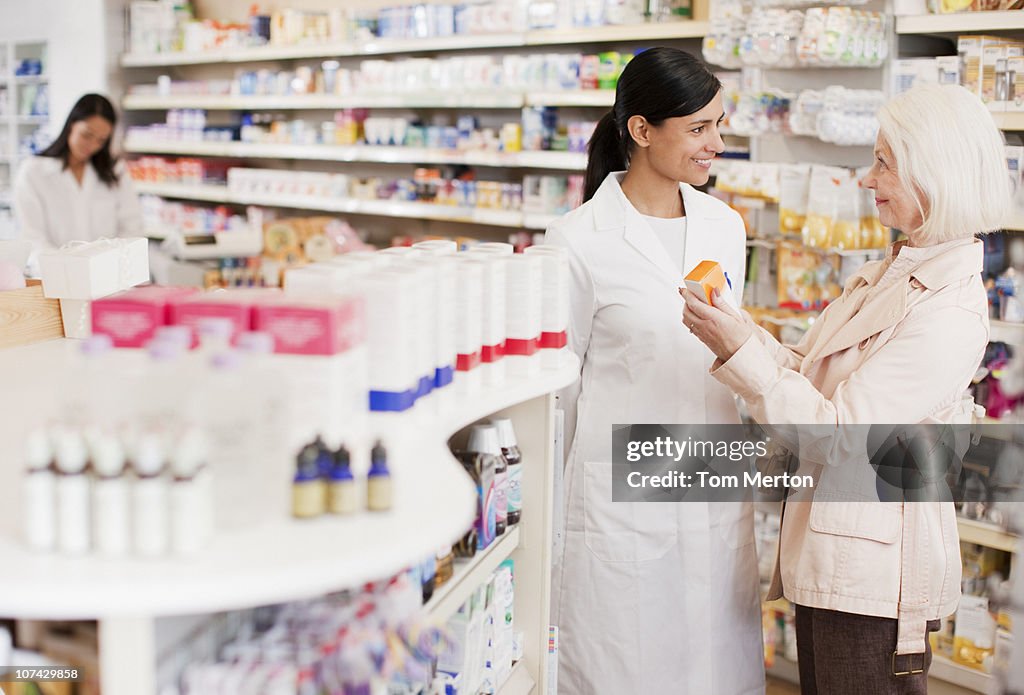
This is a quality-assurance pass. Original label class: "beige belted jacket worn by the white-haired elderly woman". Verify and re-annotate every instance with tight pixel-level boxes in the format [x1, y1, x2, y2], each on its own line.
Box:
[713, 238, 989, 654]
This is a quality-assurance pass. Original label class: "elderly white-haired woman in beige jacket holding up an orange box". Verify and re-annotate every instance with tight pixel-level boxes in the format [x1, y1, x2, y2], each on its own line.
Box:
[680, 86, 1010, 694]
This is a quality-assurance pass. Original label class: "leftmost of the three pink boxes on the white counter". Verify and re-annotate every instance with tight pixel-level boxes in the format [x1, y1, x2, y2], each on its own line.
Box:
[92, 285, 198, 347]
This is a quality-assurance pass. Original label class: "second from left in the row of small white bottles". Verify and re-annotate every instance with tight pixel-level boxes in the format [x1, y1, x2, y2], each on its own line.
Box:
[53, 428, 90, 555]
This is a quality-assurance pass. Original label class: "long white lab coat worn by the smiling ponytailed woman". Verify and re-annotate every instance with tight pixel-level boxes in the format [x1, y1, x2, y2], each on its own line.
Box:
[547, 173, 764, 695]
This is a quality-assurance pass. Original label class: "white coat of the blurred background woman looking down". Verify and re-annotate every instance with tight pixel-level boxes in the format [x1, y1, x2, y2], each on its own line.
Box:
[14, 157, 143, 251]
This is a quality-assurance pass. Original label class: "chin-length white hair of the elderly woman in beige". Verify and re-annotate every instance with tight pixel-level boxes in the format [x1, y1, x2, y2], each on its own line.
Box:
[879, 85, 1012, 244]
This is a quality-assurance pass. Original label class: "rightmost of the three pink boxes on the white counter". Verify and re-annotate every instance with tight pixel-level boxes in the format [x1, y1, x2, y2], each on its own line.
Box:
[253, 297, 367, 355]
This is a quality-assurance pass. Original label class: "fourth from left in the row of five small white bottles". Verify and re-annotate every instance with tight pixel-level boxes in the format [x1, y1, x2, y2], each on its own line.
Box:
[131, 433, 170, 558]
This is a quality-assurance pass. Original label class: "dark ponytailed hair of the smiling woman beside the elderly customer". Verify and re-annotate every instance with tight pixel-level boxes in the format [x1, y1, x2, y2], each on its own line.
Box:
[583, 46, 722, 202]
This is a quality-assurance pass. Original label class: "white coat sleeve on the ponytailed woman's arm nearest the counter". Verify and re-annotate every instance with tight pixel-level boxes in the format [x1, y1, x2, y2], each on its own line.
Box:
[544, 226, 597, 464]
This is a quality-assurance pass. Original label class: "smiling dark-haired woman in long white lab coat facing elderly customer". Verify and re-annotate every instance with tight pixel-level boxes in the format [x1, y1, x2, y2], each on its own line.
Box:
[547, 47, 764, 695]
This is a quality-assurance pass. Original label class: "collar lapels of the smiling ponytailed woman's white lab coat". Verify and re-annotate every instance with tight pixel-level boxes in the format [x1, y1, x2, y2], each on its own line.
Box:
[593, 171, 724, 284]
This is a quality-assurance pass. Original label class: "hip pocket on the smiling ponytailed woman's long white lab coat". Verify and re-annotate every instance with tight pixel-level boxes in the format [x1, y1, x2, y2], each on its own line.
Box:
[583, 462, 679, 562]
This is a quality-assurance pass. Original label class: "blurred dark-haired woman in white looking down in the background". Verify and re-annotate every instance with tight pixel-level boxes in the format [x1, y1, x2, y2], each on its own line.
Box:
[14, 94, 142, 252]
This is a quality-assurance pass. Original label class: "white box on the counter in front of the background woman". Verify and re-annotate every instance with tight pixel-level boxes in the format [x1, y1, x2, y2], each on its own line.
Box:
[39, 237, 150, 300]
